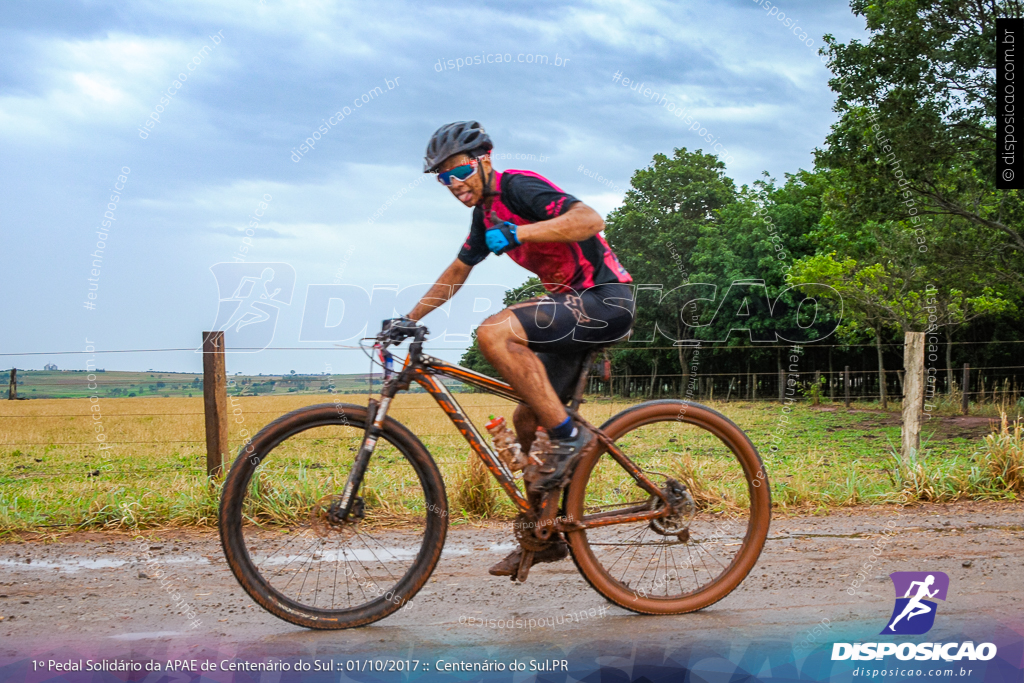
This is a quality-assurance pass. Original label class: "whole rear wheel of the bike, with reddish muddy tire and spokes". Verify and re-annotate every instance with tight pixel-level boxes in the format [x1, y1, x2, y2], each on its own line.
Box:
[565, 400, 771, 614]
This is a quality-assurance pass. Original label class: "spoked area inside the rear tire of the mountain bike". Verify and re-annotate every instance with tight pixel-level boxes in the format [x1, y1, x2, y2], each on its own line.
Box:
[582, 407, 765, 604]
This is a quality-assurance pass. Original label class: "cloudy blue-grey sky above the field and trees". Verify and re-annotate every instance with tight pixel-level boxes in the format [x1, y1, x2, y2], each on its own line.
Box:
[0, 0, 864, 374]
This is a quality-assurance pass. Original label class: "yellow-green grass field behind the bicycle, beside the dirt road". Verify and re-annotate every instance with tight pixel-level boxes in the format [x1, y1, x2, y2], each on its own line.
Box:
[0, 394, 1022, 529]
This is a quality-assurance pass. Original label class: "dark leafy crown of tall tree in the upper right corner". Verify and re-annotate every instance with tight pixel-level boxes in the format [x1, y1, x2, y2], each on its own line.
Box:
[816, 0, 1024, 283]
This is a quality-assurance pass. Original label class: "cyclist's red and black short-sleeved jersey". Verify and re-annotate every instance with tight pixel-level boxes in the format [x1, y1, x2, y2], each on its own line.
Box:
[459, 170, 633, 292]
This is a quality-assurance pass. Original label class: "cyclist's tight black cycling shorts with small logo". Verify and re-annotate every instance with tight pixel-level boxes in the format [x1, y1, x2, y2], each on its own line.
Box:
[509, 283, 636, 400]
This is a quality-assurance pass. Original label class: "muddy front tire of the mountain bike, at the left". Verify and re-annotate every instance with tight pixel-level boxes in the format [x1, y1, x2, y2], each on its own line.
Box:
[219, 403, 447, 630]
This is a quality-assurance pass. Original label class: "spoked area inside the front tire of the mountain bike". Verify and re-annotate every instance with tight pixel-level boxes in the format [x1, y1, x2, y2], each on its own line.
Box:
[232, 425, 428, 613]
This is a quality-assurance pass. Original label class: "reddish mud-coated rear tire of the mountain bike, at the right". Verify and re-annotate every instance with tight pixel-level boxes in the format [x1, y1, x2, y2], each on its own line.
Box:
[564, 399, 771, 614]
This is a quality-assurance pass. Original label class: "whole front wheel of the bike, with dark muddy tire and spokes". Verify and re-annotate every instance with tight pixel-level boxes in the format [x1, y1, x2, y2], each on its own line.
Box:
[220, 403, 447, 629]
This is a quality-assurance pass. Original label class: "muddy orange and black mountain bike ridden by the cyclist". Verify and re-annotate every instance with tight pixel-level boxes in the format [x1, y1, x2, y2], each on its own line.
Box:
[220, 326, 771, 629]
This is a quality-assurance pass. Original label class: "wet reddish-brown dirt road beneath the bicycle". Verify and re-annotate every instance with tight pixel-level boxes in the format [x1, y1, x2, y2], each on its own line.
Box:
[0, 503, 1024, 657]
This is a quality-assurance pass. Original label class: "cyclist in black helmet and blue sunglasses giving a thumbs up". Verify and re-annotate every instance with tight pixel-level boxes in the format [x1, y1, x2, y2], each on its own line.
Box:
[392, 121, 634, 577]
